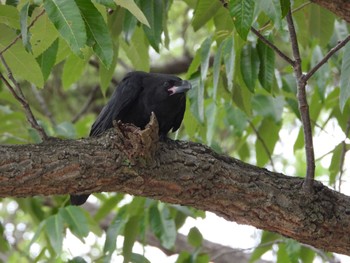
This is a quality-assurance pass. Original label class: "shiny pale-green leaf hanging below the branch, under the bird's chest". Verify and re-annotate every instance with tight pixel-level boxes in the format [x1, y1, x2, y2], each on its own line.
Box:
[149, 205, 177, 249]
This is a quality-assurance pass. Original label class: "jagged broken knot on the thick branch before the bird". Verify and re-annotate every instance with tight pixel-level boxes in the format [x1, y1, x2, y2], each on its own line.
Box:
[104, 112, 159, 165]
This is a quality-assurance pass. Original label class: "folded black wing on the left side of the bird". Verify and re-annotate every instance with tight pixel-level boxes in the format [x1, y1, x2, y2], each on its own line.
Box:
[90, 74, 142, 136]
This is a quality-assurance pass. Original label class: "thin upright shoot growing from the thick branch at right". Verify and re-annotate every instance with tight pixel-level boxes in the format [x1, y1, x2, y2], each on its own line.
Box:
[286, 11, 315, 193]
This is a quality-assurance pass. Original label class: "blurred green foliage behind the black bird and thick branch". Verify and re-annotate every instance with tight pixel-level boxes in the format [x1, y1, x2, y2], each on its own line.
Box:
[0, 0, 350, 263]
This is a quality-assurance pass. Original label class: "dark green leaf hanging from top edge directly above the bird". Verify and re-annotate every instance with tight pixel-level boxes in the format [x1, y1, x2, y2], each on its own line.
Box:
[141, 0, 164, 53]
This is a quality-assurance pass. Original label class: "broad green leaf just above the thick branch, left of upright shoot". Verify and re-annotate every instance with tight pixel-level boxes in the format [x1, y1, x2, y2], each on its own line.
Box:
[255, 119, 282, 167]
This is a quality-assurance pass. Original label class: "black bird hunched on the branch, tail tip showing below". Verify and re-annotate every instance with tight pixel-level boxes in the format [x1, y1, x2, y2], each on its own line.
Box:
[70, 71, 191, 205]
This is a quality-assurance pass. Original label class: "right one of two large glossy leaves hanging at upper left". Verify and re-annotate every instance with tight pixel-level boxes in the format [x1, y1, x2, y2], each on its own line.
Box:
[75, 0, 114, 69]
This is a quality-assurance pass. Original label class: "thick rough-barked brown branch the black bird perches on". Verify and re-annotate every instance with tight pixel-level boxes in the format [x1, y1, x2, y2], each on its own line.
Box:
[0, 120, 350, 255]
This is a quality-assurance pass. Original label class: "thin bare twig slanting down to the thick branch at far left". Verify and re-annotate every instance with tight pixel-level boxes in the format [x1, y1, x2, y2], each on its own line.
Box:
[0, 54, 48, 141]
